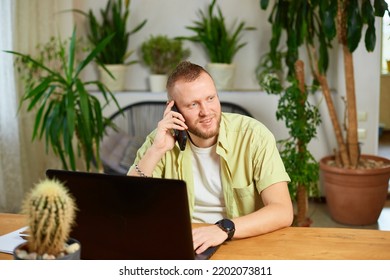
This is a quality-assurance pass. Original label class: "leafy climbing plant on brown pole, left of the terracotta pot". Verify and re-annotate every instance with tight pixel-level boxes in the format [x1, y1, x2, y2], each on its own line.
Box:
[259, 60, 321, 226]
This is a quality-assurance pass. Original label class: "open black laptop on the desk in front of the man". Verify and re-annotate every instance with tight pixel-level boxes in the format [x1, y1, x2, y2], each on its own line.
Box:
[46, 169, 217, 260]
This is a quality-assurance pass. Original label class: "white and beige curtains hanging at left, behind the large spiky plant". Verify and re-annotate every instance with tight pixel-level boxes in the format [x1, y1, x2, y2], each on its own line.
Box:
[0, 0, 73, 213]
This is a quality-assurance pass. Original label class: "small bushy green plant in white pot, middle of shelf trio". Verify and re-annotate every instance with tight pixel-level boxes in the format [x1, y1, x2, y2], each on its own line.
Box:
[140, 35, 191, 92]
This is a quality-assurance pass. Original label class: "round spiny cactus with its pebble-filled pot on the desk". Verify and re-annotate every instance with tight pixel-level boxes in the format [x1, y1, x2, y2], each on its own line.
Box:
[14, 179, 81, 260]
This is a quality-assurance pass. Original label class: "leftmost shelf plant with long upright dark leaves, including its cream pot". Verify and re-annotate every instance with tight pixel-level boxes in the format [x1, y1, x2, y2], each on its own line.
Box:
[73, 0, 147, 91]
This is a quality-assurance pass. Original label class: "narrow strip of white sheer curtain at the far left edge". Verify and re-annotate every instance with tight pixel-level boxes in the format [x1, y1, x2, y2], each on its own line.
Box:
[0, 0, 23, 211]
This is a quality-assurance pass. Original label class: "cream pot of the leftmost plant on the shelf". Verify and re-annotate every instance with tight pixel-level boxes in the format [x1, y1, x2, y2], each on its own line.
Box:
[98, 64, 127, 92]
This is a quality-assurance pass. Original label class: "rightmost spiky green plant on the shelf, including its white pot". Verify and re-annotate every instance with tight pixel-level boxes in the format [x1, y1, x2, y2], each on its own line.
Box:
[178, 0, 255, 90]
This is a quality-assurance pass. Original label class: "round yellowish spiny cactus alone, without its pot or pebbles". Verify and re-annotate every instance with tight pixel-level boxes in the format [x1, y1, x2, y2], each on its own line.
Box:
[23, 179, 76, 256]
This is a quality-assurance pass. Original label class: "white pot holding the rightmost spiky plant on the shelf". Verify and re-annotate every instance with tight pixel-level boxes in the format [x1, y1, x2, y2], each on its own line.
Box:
[206, 63, 235, 90]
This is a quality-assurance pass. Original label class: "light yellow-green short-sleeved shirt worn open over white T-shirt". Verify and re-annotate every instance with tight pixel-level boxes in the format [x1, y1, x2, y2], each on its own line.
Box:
[131, 113, 290, 219]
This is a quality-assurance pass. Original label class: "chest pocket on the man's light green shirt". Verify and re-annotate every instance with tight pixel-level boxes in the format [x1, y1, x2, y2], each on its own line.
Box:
[233, 183, 263, 216]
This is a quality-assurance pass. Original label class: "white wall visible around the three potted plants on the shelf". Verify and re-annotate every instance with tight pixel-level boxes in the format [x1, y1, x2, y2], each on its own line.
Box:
[74, 0, 270, 90]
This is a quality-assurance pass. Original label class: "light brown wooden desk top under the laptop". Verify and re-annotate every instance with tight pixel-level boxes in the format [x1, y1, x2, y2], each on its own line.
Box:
[0, 214, 390, 260]
